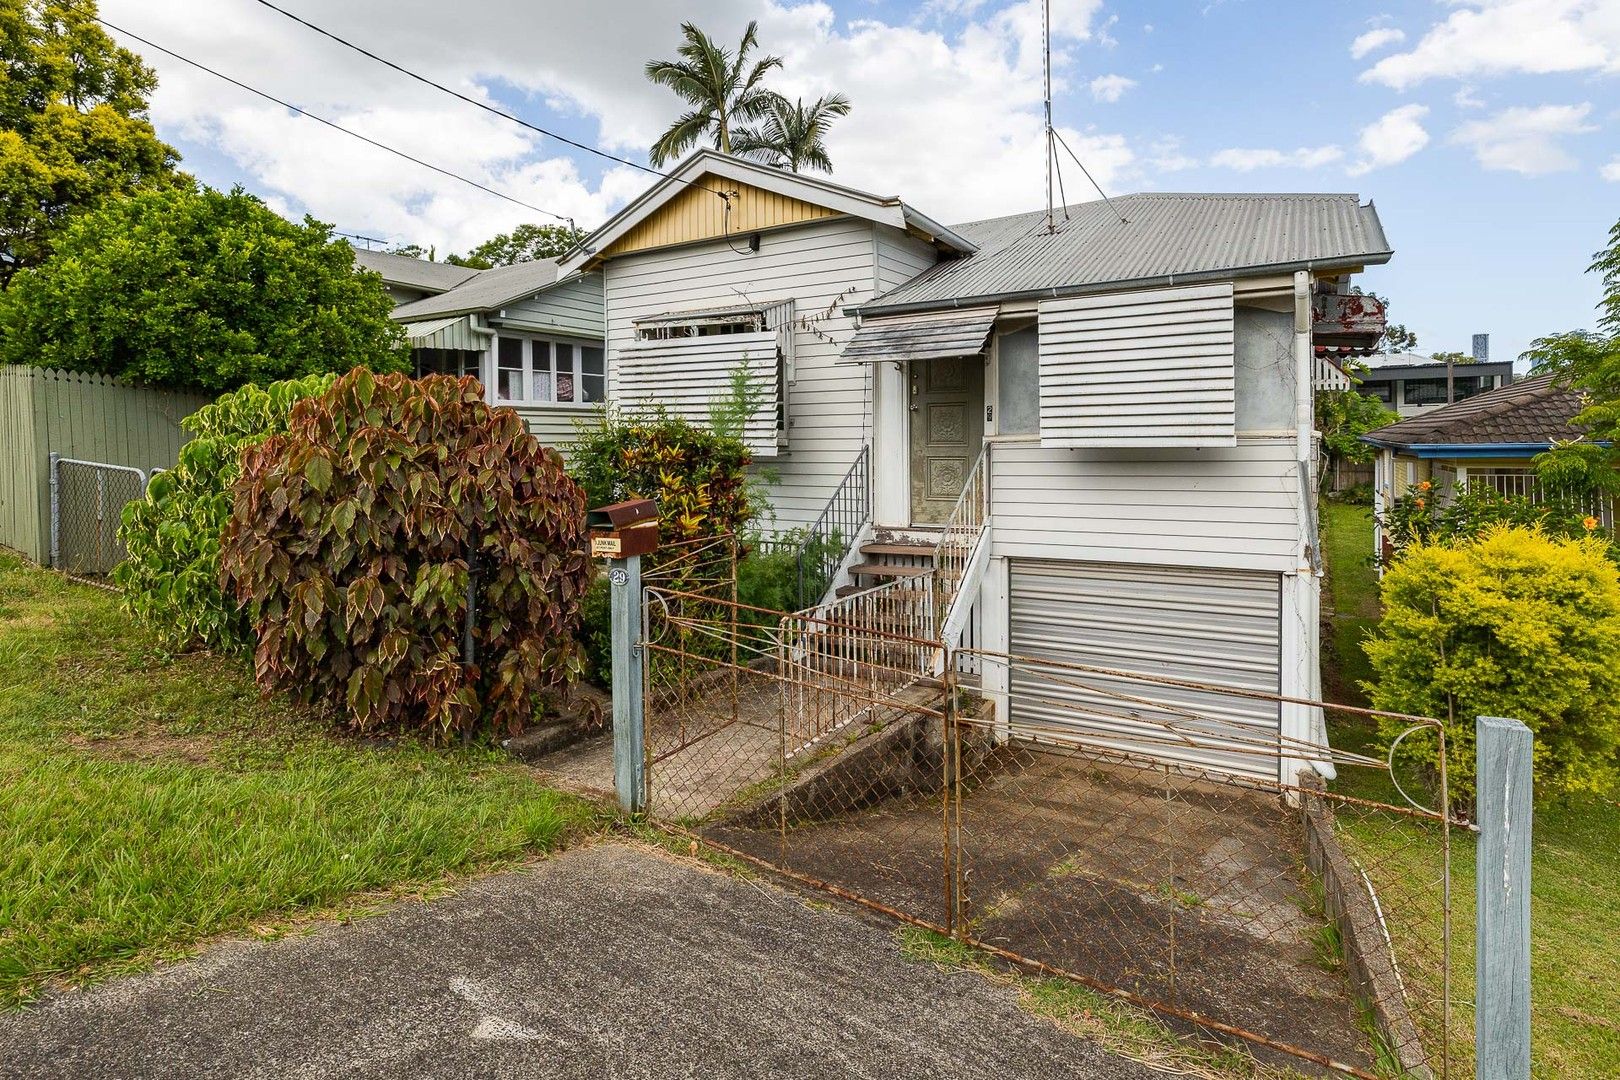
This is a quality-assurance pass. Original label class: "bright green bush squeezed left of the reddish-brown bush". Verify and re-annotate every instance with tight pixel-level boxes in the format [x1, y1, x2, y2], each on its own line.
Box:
[113, 376, 337, 651]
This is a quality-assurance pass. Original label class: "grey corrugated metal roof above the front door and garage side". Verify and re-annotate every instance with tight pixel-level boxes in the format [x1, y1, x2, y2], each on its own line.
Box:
[862, 194, 1390, 316]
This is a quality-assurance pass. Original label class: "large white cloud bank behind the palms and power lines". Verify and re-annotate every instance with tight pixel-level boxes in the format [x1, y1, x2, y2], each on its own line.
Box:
[102, 0, 1114, 251]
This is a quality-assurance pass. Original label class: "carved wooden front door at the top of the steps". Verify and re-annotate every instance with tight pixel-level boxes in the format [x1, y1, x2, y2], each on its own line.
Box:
[910, 356, 985, 525]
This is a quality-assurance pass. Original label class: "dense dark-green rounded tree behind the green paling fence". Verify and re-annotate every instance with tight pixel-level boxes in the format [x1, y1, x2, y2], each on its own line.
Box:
[0, 188, 407, 392]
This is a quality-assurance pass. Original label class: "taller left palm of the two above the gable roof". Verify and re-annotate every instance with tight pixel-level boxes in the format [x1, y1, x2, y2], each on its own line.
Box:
[646, 23, 782, 165]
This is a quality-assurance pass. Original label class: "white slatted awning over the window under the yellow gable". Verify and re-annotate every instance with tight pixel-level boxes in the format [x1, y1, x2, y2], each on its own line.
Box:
[614, 330, 778, 458]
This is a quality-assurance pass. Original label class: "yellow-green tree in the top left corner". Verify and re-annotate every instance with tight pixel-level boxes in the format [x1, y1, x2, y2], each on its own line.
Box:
[0, 0, 190, 285]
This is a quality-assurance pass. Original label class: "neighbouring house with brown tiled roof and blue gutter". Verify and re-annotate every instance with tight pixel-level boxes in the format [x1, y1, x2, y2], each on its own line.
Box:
[1362, 376, 1615, 554]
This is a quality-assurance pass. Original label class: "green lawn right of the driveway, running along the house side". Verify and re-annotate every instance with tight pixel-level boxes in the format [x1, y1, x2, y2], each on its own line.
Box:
[1322, 502, 1620, 1077]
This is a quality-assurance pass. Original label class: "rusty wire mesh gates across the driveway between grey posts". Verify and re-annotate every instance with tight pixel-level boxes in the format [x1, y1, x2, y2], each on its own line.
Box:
[643, 586, 1473, 1077]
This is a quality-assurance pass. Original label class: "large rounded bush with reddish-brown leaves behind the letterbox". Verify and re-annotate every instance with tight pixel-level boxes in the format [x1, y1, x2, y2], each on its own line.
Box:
[220, 369, 591, 738]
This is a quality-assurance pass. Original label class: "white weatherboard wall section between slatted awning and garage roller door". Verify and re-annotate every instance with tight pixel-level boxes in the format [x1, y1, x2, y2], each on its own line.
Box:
[990, 439, 1299, 572]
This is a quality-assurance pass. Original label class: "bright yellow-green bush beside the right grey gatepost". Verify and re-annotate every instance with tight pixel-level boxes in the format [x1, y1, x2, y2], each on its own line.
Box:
[1366, 526, 1620, 803]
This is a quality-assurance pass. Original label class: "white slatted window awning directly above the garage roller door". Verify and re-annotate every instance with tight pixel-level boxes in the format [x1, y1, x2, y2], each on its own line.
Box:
[1040, 282, 1236, 447]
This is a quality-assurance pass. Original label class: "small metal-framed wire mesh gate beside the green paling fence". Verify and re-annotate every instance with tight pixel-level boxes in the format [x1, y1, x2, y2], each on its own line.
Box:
[50, 455, 147, 576]
